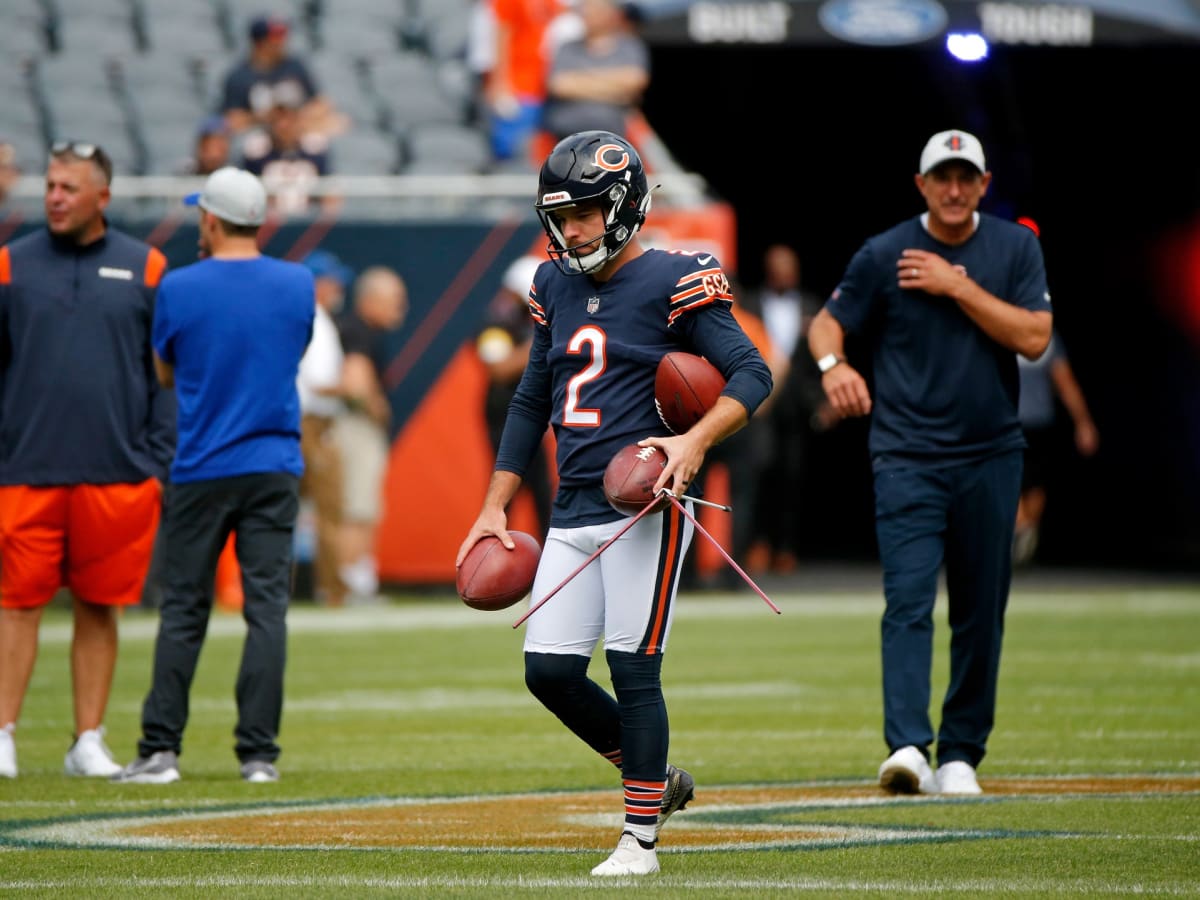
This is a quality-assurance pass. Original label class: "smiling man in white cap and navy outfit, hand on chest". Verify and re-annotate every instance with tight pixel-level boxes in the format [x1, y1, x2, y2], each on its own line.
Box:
[809, 130, 1052, 794]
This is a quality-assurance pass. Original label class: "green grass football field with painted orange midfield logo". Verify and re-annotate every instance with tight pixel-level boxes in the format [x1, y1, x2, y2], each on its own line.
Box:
[0, 578, 1200, 898]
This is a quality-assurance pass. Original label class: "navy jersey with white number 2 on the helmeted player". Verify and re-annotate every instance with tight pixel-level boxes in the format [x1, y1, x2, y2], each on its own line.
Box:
[496, 250, 772, 528]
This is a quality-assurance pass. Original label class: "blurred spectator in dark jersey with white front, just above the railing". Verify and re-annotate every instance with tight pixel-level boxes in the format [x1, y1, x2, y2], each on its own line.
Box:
[242, 91, 341, 216]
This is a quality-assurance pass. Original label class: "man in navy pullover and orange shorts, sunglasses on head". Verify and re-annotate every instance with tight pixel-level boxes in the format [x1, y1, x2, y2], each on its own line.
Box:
[0, 142, 175, 778]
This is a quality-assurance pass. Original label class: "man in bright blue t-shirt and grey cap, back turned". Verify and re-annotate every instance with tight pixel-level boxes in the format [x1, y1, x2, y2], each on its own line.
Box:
[113, 167, 316, 784]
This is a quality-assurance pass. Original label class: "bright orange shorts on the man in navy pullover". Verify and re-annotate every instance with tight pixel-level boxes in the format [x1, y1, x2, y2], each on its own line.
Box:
[0, 478, 162, 610]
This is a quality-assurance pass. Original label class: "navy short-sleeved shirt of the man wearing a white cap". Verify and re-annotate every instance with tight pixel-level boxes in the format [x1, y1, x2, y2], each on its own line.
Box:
[826, 215, 1050, 469]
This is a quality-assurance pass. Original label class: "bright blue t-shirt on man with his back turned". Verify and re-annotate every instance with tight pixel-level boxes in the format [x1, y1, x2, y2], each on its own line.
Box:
[154, 257, 316, 482]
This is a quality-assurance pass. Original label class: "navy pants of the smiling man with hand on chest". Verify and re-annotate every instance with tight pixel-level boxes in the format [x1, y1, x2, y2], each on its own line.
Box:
[875, 450, 1021, 766]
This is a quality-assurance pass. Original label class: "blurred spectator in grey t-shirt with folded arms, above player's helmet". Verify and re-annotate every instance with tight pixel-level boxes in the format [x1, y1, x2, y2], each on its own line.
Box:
[542, 0, 650, 145]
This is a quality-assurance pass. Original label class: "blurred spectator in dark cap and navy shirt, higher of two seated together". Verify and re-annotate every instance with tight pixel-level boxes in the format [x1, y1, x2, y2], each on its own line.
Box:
[218, 16, 348, 137]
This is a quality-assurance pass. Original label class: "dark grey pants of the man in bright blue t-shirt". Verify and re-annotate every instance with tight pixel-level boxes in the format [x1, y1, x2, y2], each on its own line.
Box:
[138, 473, 299, 762]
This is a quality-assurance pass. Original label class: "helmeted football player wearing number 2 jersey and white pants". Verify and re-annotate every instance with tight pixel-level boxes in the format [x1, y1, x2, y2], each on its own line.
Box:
[457, 131, 772, 876]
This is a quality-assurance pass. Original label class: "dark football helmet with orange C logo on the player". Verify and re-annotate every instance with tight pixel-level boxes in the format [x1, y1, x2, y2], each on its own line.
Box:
[534, 131, 650, 275]
